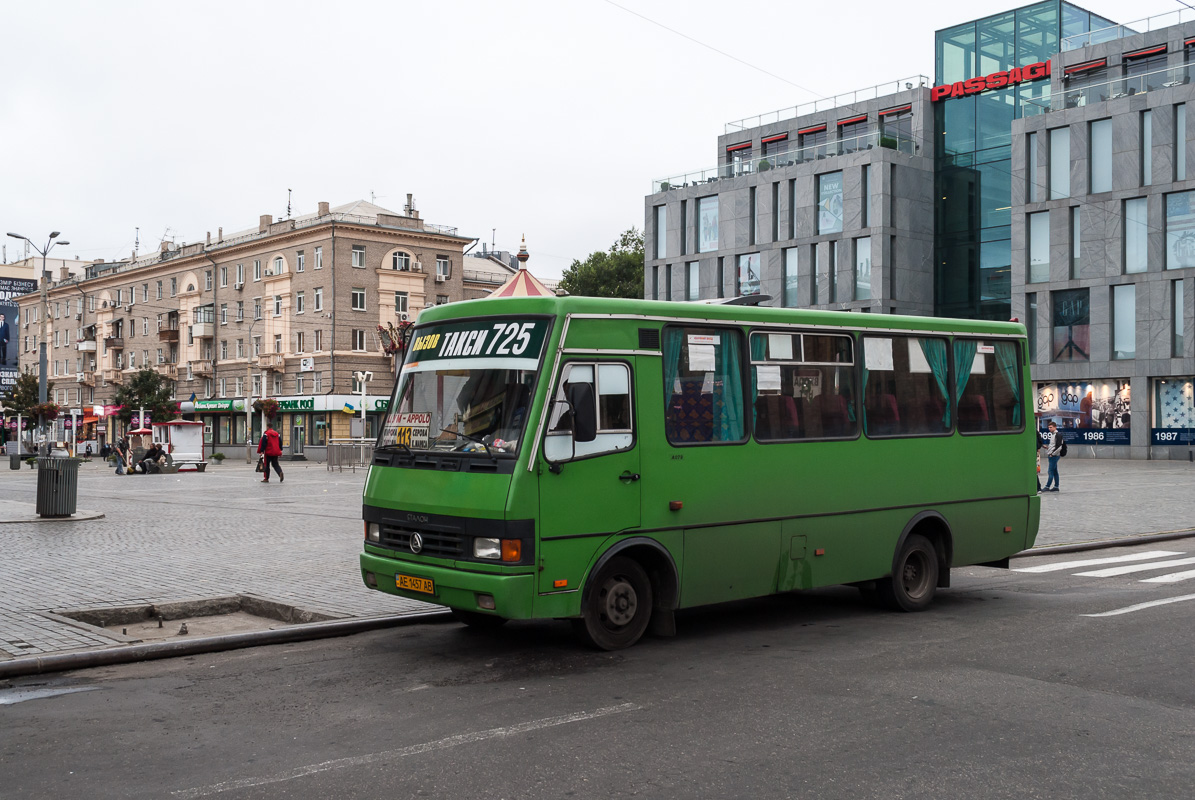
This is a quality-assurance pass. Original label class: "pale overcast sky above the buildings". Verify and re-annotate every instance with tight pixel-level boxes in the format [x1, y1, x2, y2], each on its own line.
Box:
[0, 0, 1161, 277]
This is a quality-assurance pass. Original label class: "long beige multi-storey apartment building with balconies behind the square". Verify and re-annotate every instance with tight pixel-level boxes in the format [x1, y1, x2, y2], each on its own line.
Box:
[13, 195, 494, 458]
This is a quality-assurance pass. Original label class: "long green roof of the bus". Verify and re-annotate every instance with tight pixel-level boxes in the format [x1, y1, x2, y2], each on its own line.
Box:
[417, 295, 1025, 336]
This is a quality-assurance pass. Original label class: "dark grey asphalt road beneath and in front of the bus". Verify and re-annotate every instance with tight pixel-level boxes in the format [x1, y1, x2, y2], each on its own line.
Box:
[0, 541, 1195, 800]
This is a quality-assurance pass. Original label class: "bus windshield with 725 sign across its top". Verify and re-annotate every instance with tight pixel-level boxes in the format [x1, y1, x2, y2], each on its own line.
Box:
[378, 318, 551, 458]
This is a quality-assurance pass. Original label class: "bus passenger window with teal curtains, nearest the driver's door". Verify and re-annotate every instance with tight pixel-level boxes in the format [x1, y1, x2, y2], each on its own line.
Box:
[663, 326, 746, 445]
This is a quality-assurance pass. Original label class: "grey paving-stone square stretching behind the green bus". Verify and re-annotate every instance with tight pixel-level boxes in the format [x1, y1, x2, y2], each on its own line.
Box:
[0, 458, 1195, 660]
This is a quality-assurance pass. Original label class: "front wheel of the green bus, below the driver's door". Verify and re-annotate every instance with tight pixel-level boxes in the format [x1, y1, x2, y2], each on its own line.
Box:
[574, 556, 651, 651]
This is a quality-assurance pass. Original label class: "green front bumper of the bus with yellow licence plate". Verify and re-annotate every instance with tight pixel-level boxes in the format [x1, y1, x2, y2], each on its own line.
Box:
[361, 552, 535, 619]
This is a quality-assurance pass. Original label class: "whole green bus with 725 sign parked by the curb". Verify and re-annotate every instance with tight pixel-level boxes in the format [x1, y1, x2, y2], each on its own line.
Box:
[361, 297, 1040, 649]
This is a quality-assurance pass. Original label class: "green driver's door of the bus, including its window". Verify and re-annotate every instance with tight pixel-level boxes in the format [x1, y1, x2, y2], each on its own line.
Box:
[539, 359, 642, 591]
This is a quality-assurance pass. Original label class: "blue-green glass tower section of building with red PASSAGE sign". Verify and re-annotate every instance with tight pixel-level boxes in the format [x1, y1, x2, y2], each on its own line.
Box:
[933, 0, 1104, 319]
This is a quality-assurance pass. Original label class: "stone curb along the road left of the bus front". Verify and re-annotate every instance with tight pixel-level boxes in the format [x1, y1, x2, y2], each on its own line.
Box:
[0, 610, 451, 679]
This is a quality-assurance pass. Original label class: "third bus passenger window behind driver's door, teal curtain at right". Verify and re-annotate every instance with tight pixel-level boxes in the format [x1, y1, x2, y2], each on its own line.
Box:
[863, 336, 950, 436]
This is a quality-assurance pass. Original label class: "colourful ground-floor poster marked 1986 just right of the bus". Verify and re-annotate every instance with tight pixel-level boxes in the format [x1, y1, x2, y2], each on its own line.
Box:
[1034, 380, 1132, 445]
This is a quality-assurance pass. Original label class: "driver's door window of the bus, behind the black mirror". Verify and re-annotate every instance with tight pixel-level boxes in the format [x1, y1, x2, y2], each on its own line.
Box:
[544, 362, 635, 462]
